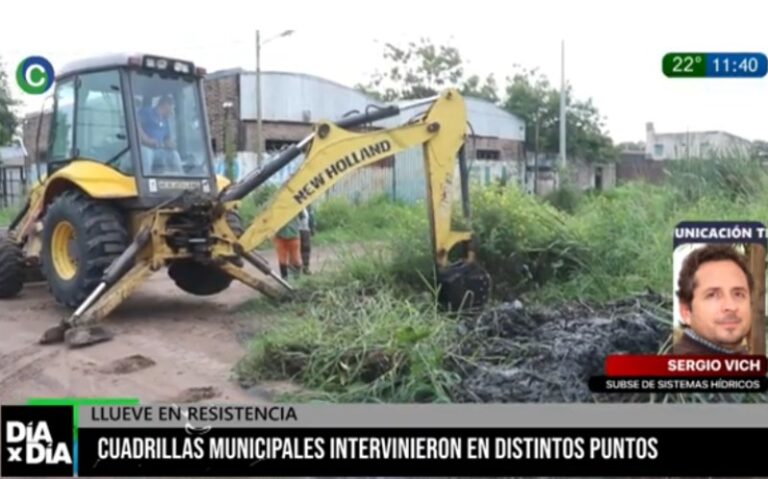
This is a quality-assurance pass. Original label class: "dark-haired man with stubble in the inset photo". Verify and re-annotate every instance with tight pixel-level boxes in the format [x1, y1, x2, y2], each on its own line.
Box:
[672, 244, 754, 354]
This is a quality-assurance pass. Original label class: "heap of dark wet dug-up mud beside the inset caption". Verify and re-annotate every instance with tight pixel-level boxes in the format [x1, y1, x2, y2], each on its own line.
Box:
[453, 293, 672, 403]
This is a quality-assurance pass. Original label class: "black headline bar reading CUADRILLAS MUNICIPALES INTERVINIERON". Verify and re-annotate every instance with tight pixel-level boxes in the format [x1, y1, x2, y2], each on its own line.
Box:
[78, 428, 768, 477]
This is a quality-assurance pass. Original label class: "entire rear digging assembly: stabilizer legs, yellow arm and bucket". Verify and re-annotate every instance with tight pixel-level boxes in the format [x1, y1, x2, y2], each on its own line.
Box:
[40, 90, 490, 347]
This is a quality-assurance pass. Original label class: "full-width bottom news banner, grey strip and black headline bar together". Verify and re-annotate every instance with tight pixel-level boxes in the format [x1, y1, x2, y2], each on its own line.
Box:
[0, 404, 768, 477]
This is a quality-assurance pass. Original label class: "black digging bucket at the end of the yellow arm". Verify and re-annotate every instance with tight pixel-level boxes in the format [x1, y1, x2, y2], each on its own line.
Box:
[437, 262, 491, 311]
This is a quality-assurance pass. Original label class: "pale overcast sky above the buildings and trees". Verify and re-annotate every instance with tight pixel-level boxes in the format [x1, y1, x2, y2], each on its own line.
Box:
[0, 0, 768, 142]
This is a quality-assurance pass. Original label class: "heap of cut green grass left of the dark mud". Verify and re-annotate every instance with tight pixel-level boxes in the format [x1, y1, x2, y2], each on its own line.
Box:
[237, 282, 457, 402]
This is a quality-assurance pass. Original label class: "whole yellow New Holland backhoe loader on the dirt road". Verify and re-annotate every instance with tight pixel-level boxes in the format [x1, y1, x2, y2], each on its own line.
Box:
[0, 55, 490, 347]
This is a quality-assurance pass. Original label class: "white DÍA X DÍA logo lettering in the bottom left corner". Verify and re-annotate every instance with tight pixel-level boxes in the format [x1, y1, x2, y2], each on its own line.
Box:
[5, 421, 72, 464]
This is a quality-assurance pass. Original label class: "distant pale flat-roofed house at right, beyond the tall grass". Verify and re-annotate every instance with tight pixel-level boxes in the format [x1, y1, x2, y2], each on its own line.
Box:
[645, 122, 752, 161]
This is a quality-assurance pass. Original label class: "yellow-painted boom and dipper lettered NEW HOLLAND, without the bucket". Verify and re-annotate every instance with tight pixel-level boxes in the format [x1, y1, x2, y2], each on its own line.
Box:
[239, 92, 470, 266]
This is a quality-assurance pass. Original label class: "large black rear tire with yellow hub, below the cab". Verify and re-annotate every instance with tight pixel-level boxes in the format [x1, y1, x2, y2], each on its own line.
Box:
[40, 190, 131, 308]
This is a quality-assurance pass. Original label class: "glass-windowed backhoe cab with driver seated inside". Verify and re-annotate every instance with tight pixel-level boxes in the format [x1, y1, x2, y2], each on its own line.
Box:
[47, 55, 216, 201]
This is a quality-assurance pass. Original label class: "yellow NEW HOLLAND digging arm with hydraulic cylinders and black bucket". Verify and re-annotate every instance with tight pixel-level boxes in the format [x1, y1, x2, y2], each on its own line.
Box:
[222, 90, 490, 308]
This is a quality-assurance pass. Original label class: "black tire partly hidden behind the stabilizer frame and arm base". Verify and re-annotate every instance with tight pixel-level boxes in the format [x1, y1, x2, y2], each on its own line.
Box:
[168, 210, 243, 296]
